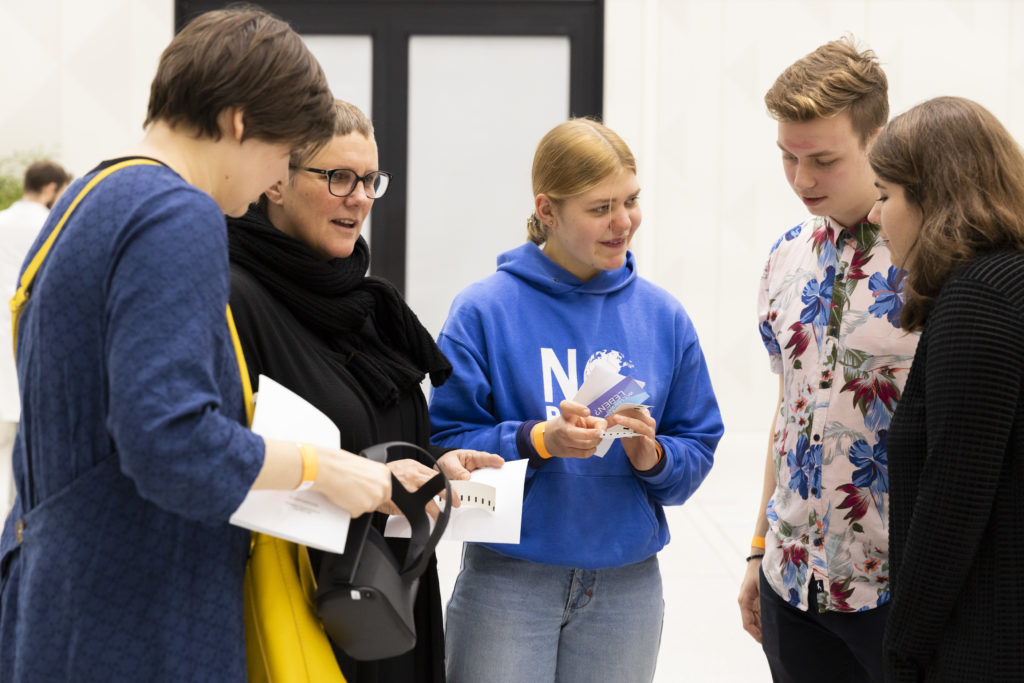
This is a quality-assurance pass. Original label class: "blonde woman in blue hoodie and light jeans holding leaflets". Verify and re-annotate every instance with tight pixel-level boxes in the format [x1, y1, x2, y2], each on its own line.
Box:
[430, 119, 723, 683]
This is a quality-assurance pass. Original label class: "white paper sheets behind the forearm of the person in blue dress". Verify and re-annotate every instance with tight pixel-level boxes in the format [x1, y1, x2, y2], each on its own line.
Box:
[230, 375, 351, 553]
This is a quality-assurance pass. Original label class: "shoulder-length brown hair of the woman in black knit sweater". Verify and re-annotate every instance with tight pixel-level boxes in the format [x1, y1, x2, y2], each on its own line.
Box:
[868, 97, 1024, 331]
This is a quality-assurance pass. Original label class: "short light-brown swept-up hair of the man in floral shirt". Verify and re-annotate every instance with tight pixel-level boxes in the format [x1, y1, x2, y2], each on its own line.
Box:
[765, 36, 889, 144]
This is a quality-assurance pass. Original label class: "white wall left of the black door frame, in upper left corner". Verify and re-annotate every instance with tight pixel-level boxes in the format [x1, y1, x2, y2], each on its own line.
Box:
[0, 0, 174, 176]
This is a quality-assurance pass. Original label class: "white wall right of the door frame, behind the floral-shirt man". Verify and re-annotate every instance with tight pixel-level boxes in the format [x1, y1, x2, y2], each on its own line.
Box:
[605, 0, 1024, 440]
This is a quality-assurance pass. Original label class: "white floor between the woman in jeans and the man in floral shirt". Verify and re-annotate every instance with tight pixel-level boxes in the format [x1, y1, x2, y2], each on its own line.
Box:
[437, 434, 771, 683]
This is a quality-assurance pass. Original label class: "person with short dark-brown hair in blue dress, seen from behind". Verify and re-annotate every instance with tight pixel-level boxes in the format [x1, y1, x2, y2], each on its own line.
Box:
[0, 7, 390, 683]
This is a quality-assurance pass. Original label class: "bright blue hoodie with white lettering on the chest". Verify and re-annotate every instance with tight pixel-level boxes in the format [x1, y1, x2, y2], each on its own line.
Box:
[430, 243, 723, 569]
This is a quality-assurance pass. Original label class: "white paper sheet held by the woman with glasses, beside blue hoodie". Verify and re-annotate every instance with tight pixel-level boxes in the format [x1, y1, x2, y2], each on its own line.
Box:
[384, 460, 527, 543]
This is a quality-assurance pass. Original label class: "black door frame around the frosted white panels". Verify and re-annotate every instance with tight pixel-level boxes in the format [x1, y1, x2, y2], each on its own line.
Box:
[174, 0, 604, 292]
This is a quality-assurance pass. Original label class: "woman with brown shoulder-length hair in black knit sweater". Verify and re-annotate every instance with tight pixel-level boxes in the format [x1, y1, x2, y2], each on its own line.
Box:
[868, 97, 1024, 682]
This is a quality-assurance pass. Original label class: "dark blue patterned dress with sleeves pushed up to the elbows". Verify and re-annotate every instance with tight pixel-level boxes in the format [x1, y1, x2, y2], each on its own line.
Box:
[0, 158, 263, 683]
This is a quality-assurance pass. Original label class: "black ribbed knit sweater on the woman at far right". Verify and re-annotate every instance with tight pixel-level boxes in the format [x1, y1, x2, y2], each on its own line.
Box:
[885, 252, 1024, 682]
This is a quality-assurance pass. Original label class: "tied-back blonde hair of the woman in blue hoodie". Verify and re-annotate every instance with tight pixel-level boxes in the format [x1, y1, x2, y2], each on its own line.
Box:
[526, 118, 637, 245]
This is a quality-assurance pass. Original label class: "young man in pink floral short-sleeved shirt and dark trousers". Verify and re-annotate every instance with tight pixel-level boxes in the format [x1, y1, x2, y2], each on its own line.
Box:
[739, 38, 918, 682]
